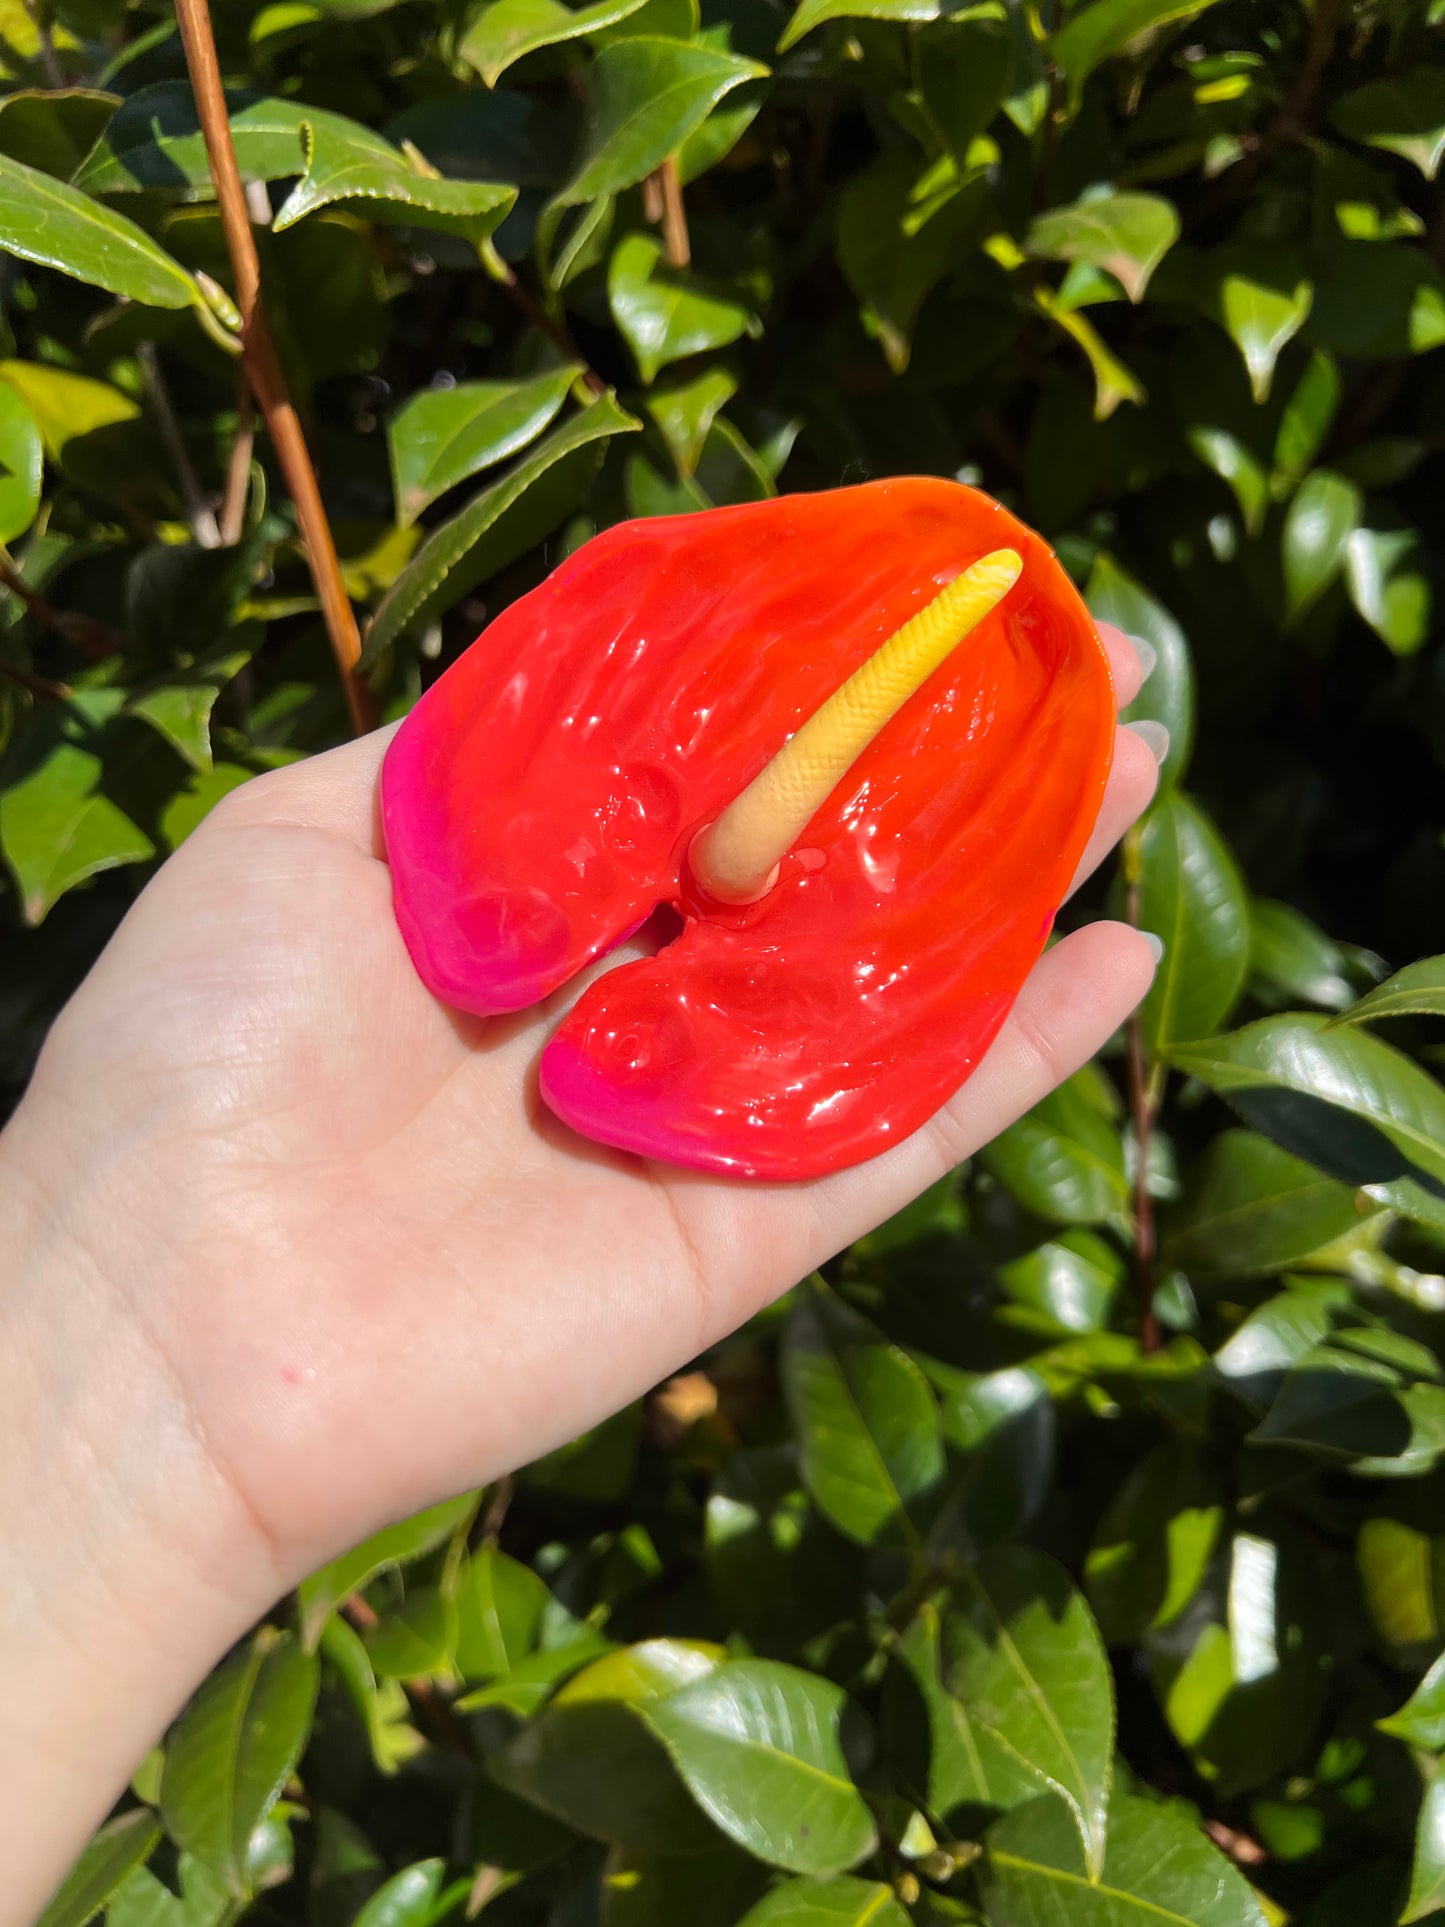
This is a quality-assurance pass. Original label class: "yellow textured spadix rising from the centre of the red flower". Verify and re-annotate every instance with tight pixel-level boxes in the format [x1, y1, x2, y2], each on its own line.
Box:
[692, 549, 1023, 904]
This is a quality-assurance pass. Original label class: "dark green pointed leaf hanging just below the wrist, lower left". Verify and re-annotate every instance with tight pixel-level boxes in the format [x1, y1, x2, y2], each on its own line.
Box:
[160, 1630, 320, 1900]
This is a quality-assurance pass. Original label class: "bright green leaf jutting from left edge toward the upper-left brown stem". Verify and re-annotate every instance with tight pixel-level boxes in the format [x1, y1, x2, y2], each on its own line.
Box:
[0, 154, 206, 308]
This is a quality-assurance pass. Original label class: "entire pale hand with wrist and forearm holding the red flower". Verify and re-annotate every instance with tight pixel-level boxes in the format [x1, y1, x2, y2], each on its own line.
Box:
[0, 630, 1158, 1927]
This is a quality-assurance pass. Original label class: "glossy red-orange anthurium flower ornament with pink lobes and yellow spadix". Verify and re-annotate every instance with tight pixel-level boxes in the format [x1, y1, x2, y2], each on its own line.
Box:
[381, 478, 1114, 1179]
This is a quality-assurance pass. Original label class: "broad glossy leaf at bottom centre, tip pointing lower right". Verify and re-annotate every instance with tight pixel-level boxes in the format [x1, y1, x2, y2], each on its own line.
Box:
[644, 1659, 877, 1877]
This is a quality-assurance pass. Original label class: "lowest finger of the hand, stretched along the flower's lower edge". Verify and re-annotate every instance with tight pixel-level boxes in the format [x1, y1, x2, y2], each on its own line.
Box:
[674, 923, 1154, 1330]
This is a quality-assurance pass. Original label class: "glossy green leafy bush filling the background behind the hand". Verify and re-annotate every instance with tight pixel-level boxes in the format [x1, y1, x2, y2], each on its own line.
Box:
[0, 0, 1445, 1927]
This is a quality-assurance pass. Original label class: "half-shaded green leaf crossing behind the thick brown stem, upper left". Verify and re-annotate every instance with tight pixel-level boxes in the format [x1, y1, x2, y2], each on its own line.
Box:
[73, 81, 397, 200]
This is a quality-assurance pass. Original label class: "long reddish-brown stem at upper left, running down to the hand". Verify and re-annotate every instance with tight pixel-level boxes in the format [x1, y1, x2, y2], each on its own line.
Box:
[175, 0, 378, 736]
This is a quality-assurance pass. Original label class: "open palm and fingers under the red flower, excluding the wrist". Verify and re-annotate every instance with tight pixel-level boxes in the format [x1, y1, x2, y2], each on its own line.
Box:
[31, 632, 1156, 1578]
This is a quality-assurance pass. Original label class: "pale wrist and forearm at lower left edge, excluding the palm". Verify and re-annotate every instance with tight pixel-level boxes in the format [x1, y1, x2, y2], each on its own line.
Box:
[0, 1100, 281, 1927]
